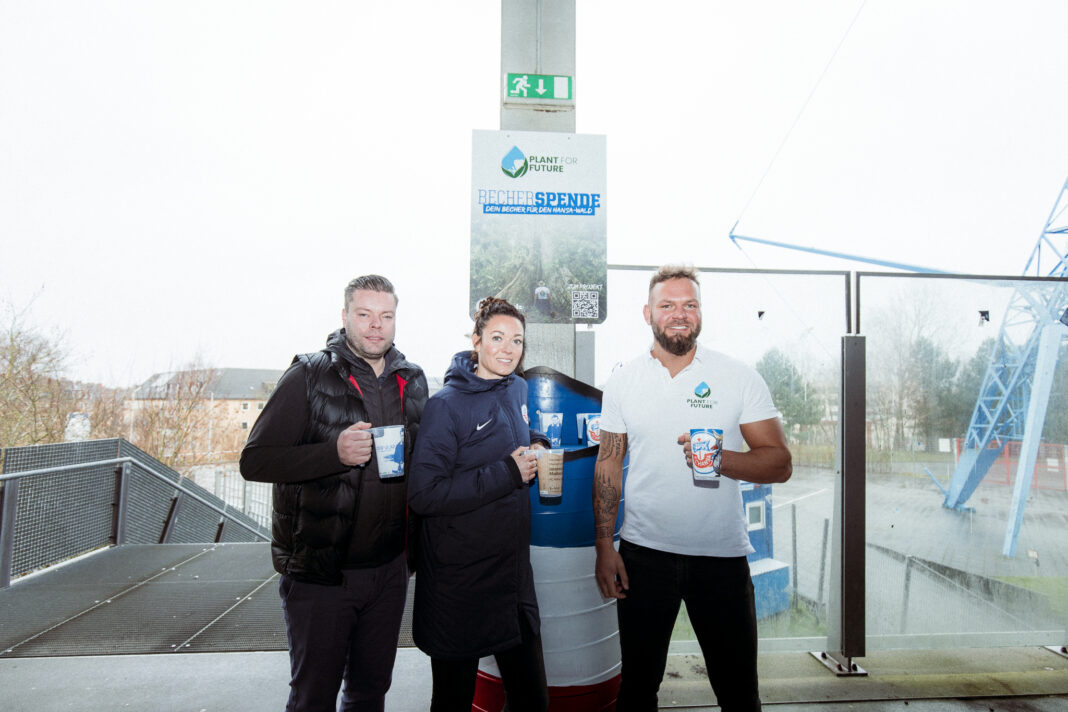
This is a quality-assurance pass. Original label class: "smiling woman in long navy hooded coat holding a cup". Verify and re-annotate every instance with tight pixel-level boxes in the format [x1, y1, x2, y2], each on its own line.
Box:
[408, 298, 548, 712]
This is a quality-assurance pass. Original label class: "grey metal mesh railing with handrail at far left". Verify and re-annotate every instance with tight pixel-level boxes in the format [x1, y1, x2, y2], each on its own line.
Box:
[0, 439, 270, 588]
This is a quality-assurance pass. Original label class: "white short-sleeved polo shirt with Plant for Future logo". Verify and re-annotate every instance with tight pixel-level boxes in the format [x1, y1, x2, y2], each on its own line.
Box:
[601, 344, 779, 556]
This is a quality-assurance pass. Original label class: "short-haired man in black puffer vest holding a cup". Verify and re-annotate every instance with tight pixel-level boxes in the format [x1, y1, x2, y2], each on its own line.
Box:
[241, 274, 427, 712]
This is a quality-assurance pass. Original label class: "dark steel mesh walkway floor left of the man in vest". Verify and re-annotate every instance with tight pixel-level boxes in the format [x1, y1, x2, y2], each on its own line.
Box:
[0, 543, 413, 658]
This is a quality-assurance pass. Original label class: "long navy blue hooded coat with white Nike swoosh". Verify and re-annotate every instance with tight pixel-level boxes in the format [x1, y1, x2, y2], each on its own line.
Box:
[408, 351, 548, 660]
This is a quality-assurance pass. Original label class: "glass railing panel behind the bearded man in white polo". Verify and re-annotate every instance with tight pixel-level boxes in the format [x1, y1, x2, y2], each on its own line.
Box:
[595, 270, 848, 652]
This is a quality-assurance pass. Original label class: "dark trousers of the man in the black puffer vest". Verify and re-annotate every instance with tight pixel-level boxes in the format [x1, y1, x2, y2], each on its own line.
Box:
[279, 554, 408, 712]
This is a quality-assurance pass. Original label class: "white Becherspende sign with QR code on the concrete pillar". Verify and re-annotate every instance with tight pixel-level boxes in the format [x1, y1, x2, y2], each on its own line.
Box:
[470, 131, 608, 323]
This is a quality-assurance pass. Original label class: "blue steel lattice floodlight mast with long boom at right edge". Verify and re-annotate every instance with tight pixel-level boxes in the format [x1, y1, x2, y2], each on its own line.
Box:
[731, 180, 1068, 556]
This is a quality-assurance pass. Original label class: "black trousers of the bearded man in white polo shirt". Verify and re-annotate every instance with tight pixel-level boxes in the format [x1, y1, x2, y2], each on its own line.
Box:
[616, 541, 760, 712]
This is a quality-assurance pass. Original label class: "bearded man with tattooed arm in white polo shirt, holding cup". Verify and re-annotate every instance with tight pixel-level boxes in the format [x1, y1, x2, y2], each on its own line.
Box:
[594, 266, 792, 712]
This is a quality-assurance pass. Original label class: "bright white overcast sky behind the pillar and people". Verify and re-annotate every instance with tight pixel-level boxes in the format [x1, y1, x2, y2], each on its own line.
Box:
[0, 0, 1068, 385]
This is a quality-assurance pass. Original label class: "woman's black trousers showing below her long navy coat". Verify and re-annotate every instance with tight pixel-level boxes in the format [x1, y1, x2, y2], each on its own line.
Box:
[430, 613, 549, 712]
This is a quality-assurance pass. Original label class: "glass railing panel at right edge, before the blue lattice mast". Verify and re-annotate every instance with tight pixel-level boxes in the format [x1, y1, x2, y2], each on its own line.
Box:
[859, 274, 1068, 650]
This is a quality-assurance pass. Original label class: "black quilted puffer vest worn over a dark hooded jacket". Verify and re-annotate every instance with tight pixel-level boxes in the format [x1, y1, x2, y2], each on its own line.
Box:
[271, 332, 427, 585]
